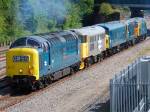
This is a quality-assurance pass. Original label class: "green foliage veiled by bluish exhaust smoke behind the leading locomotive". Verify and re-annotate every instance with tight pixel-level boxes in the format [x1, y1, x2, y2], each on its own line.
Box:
[0, 0, 94, 42]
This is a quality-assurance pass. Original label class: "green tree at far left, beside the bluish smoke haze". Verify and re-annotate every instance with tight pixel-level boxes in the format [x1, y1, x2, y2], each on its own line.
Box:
[0, 0, 30, 40]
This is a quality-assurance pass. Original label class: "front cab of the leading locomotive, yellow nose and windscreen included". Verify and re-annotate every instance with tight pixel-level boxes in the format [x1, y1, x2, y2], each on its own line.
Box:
[6, 37, 48, 86]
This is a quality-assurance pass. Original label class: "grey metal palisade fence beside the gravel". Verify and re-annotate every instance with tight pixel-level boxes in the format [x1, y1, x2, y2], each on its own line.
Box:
[110, 57, 150, 112]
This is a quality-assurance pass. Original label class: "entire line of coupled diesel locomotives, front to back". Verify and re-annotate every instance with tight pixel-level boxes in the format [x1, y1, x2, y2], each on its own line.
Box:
[6, 18, 147, 90]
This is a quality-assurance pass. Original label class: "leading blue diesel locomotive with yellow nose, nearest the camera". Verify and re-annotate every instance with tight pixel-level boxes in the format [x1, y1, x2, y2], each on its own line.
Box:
[6, 31, 80, 89]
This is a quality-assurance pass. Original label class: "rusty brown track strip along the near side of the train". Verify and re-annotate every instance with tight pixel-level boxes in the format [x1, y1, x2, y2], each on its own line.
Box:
[0, 42, 145, 111]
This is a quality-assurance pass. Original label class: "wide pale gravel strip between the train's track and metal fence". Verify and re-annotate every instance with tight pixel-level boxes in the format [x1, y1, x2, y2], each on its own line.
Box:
[6, 36, 150, 112]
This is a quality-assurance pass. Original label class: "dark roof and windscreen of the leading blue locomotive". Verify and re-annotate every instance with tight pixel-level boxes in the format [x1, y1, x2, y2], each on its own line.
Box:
[10, 31, 77, 48]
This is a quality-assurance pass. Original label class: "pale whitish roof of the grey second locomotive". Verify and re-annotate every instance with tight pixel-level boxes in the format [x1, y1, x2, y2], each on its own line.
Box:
[74, 26, 105, 36]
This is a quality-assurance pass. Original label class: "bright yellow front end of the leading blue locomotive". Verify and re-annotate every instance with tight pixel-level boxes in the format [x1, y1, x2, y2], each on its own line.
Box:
[6, 48, 39, 80]
